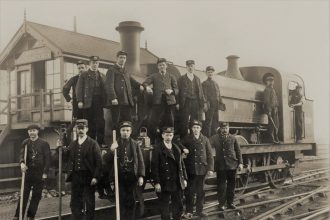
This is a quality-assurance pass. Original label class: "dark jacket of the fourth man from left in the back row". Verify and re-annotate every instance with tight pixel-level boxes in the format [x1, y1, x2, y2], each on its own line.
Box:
[143, 72, 179, 105]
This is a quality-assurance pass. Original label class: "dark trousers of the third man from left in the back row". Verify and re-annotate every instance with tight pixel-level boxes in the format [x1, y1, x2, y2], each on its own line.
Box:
[111, 105, 132, 130]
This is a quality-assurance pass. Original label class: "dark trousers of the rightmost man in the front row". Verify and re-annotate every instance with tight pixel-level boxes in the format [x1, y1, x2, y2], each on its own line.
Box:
[217, 170, 236, 206]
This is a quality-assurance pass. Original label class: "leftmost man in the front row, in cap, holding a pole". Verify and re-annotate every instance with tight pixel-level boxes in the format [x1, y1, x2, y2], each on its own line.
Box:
[14, 124, 51, 220]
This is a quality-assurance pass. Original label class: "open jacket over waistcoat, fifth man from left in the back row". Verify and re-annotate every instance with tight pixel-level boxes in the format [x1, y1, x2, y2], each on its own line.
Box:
[178, 74, 206, 110]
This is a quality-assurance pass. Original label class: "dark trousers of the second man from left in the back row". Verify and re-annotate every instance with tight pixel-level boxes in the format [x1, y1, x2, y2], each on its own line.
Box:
[83, 96, 105, 145]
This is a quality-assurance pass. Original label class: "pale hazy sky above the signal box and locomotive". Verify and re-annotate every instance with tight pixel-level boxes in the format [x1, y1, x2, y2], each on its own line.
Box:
[0, 0, 329, 143]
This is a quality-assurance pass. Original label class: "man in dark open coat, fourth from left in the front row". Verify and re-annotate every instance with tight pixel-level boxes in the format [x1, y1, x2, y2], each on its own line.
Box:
[151, 127, 187, 220]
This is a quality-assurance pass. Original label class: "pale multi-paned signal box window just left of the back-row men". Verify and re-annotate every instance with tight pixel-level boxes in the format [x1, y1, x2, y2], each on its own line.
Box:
[46, 58, 62, 105]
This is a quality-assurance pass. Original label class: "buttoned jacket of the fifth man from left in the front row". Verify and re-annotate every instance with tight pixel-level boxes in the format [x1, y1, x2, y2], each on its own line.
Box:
[182, 134, 214, 175]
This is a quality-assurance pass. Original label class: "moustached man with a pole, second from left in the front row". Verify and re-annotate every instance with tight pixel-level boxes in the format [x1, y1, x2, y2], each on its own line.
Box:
[63, 119, 102, 220]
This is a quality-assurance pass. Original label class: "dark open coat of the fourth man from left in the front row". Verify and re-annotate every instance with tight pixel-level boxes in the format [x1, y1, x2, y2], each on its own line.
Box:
[151, 142, 187, 191]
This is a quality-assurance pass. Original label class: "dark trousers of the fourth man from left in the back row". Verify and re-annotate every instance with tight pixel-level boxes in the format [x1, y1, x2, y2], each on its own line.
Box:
[148, 96, 175, 137]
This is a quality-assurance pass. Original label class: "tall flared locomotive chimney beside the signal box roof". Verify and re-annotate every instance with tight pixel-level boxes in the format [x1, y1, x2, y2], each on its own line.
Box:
[116, 21, 144, 75]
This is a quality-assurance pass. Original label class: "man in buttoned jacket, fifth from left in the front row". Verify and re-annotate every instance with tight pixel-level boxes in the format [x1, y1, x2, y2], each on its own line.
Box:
[182, 120, 214, 219]
